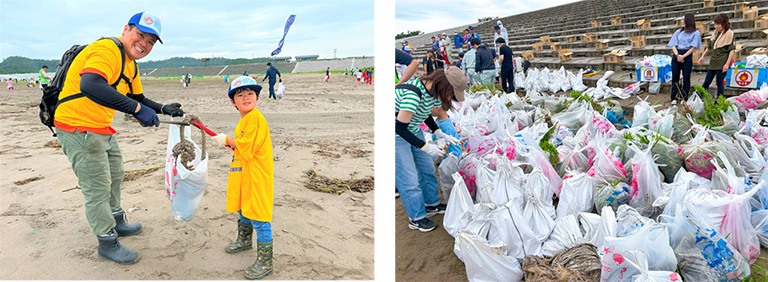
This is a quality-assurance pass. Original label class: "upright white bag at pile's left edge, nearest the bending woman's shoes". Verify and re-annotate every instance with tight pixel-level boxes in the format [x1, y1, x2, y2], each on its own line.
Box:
[443, 172, 472, 237]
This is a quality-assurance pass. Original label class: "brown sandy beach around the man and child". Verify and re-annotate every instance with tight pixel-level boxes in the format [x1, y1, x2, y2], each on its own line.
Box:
[0, 74, 374, 280]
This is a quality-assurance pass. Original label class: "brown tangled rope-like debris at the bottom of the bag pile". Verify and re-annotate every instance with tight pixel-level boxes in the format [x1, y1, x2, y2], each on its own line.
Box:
[523, 243, 602, 282]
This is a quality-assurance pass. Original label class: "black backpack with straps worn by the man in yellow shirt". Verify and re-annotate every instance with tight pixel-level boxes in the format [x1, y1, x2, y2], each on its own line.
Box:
[40, 37, 139, 137]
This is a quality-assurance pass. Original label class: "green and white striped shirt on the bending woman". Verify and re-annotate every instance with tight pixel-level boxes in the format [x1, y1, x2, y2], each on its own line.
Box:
[395, 78, 441, 135]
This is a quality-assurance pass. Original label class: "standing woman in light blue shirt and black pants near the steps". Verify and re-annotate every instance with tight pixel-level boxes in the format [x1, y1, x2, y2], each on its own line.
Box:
[667, 13, 701, 101]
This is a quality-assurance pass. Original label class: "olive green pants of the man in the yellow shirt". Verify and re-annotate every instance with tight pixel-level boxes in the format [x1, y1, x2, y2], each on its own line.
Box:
[56, 128, 125, 235]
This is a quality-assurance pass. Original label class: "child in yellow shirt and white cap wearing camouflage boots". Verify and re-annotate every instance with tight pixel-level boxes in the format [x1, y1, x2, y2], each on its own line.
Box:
[213, 76, 274, 279]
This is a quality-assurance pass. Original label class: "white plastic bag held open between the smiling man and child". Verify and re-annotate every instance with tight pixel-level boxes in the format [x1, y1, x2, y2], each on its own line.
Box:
[165, 124, 208, 221]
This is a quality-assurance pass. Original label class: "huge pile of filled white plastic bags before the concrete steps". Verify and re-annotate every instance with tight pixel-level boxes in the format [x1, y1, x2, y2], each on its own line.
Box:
[438, 83, 768, 281]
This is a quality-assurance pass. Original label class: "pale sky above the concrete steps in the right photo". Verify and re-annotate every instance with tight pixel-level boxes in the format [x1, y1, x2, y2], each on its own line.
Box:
[395, 0, 577, 33]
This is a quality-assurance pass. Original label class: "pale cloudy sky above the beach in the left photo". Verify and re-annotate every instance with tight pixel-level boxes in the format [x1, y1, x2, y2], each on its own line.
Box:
[0, 0, 374, 61]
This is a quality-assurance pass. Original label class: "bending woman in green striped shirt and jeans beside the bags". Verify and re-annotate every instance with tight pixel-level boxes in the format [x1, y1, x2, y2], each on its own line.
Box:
[395, 66, 467, 232]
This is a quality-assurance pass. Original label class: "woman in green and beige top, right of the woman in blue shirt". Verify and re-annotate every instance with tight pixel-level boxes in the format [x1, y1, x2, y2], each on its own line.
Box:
[696, 13, 736, 97]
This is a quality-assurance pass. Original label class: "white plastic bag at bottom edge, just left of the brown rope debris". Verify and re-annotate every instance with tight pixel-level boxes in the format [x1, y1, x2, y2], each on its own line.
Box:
[454, 230, 523, 281]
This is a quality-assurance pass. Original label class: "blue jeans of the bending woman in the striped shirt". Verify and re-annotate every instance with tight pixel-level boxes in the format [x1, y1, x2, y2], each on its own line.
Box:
[395, 130, 440, 221]
